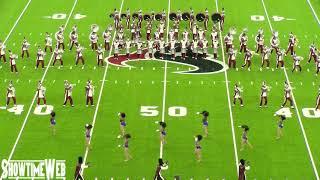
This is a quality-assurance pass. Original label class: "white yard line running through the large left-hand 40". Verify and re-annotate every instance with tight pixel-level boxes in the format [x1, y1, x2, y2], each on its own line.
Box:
[0, 0, 78, 180]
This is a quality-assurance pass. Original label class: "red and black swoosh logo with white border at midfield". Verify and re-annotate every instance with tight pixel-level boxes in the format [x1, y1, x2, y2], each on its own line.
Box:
[106, 47, 228, 75]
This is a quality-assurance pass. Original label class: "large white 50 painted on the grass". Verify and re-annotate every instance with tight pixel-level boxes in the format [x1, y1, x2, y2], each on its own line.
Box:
[140, 106, 187, 117]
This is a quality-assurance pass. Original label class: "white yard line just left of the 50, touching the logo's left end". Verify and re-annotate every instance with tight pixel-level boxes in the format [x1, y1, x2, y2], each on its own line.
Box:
[81, 0, 124, 174]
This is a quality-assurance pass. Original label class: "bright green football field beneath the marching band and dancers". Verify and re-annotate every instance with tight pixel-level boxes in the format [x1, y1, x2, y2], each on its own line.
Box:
[0, 0, 320, 180]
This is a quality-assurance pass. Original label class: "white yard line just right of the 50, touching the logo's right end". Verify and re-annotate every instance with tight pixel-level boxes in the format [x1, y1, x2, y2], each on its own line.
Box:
[215, 0, 239, 173]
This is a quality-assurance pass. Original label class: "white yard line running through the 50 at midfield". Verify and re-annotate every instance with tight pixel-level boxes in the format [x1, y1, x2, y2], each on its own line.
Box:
[159, 0, 171, 158]
